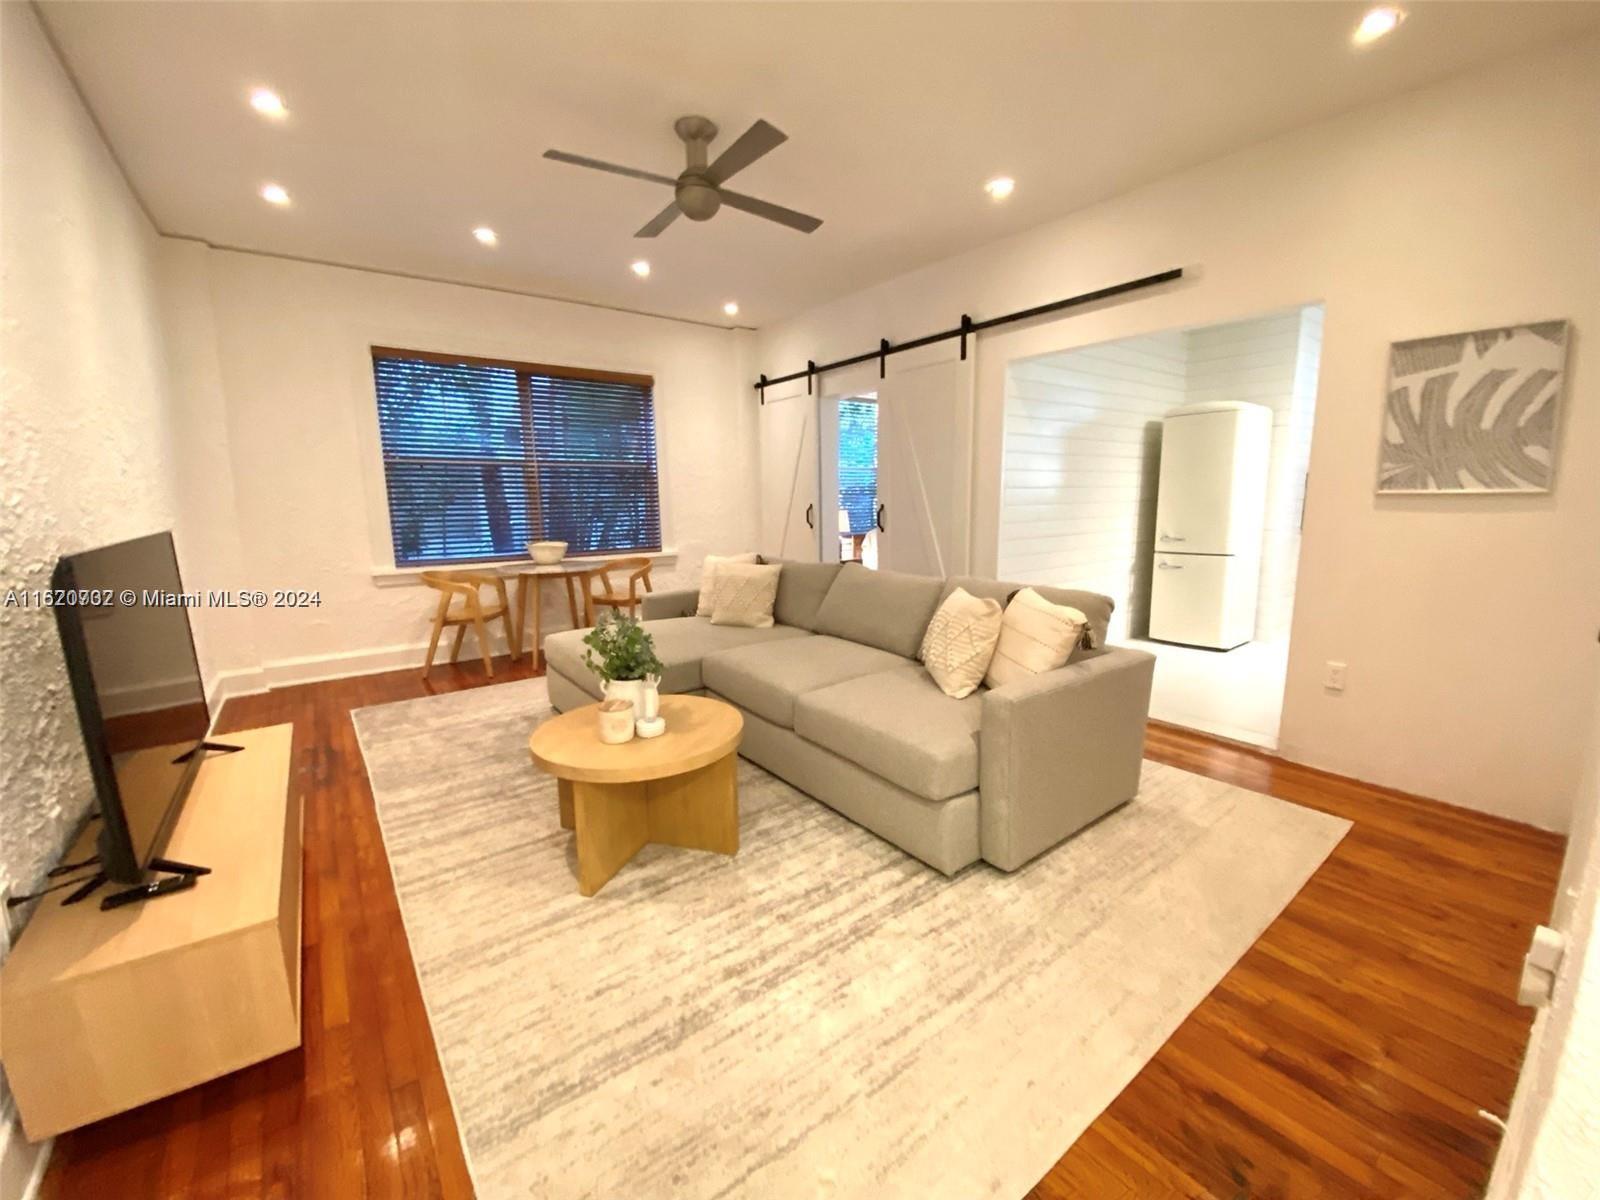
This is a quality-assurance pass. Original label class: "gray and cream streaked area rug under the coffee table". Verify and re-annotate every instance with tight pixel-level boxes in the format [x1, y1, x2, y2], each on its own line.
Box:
[355, 680, 1349, 1200]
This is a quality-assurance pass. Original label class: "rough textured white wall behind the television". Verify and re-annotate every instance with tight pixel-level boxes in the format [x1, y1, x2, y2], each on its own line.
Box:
[0, 5, 176, 1200]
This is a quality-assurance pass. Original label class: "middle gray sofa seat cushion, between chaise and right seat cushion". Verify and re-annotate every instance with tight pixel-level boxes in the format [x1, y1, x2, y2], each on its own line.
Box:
[701, 626, 906, 730]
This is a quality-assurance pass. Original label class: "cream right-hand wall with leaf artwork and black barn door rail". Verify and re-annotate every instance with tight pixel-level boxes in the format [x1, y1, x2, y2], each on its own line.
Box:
[757, 38, 1600, 829]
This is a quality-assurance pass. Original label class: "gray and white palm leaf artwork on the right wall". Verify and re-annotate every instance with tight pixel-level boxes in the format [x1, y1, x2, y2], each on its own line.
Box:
[1378, 322, 1568, 491]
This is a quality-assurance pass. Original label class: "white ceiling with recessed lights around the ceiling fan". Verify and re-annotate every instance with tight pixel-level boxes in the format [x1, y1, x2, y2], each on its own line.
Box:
[42, 0, 1600, 325]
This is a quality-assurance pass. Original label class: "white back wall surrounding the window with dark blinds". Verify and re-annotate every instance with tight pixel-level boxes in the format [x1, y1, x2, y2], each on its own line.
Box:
[190, 251, 757, 683]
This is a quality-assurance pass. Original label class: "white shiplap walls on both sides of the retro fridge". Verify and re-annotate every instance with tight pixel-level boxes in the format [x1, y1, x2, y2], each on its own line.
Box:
[998, 307, 1322, 640]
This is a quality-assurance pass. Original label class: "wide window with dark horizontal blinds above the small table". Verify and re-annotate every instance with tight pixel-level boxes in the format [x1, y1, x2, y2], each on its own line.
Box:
[373, 347, 661, 566]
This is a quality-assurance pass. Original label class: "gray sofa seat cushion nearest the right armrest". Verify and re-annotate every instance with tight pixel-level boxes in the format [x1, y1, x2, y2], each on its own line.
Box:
[795, 664, 982, 800]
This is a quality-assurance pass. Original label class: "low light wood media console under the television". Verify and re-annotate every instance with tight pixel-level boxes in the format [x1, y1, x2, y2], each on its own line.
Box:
[0, 725, 301, 1141]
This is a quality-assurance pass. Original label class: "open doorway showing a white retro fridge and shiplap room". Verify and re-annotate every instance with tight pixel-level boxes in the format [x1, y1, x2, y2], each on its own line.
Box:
[997, 304, 1323, 749]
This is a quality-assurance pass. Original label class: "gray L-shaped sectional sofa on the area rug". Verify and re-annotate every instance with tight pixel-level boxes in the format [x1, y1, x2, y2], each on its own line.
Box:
[544, 563, 1155, 874]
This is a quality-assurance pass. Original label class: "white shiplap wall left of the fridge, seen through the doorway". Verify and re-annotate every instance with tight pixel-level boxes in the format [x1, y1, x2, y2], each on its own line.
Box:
[995, 331, 1186, 640]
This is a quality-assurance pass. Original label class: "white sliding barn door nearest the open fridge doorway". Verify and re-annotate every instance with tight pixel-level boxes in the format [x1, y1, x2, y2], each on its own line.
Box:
[878, 342, 974, 576]
